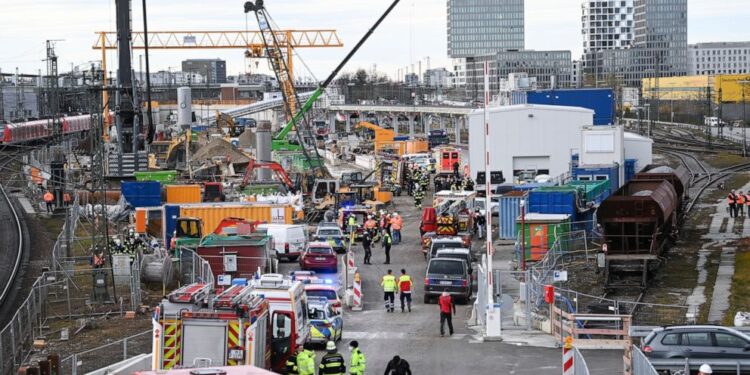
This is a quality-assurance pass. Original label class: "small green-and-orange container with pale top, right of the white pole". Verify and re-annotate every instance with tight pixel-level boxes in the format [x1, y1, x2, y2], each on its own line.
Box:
[516, 213, 570, 262]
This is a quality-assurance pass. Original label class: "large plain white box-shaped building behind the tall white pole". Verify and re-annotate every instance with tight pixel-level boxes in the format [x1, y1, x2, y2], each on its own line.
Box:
[469, 104, 594, 182]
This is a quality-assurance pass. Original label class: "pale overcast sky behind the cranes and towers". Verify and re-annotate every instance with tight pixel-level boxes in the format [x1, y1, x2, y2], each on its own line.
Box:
[0, 0, 750, 80]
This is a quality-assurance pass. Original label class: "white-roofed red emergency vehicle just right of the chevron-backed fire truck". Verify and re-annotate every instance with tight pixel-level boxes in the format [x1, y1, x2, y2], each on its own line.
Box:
[250, 273, 310, 372]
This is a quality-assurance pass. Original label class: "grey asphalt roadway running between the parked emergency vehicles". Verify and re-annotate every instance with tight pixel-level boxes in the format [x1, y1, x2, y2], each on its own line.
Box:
[281, 196, 622, 375]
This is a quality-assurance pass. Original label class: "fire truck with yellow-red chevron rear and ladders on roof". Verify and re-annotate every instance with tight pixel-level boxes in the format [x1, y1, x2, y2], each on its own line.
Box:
[152, 283, 272, 370]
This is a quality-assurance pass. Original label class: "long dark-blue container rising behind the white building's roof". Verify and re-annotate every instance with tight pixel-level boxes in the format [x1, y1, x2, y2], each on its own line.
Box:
[526, 89, 615, 125]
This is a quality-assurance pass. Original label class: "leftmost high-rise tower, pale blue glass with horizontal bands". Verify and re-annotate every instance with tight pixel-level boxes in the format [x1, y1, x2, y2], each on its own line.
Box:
[447, 0, 524, 58]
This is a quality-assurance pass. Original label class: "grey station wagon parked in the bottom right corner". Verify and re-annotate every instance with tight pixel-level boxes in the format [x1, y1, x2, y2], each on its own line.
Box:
[642, 325, 750, 359]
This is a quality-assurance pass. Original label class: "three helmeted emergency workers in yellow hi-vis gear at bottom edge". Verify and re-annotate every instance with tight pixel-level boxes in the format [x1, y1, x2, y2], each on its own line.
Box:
[286, 340, 366, 375]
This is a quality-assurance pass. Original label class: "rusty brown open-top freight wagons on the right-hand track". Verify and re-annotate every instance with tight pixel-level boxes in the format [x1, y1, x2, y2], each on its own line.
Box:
[597, 166, 690, 288]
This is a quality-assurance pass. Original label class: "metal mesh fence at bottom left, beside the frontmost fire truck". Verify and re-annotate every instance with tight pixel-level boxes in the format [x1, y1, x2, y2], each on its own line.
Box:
[61, 330, 152, 375]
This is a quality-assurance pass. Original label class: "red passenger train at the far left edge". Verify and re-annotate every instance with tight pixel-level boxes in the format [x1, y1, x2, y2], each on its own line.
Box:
[0, 115, 91, 144]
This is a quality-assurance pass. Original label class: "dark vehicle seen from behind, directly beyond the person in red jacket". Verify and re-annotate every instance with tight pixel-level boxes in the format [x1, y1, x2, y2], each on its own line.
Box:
[424, 258, 472, 303]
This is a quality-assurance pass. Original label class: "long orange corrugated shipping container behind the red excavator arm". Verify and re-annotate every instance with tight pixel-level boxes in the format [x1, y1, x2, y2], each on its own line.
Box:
[180, 203, 294, 234]
